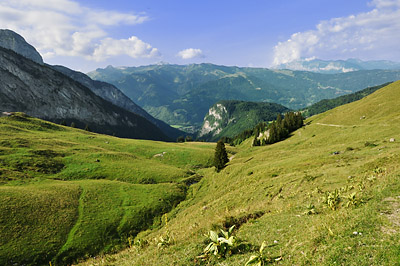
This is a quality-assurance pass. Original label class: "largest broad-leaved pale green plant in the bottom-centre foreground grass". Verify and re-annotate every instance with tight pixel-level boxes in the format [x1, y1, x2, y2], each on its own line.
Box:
[204, 225, 236, 258]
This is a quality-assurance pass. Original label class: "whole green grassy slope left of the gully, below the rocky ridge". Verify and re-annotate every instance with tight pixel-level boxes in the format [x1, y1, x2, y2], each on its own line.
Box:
[0, 114, 214, 265]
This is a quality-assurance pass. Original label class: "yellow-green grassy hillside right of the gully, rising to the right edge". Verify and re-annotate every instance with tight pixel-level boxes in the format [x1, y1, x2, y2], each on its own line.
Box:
[78, 82, 400, 265]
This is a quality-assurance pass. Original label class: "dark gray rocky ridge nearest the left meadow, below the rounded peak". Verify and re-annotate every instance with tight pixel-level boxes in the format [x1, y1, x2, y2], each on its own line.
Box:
[0, 45, 168, 140]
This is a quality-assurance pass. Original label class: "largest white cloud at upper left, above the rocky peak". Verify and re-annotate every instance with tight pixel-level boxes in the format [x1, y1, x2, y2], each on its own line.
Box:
[0, 0, 158, 61]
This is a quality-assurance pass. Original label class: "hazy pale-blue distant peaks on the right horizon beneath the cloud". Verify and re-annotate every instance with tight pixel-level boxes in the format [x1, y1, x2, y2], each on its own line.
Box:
[274, 57, 400, 74]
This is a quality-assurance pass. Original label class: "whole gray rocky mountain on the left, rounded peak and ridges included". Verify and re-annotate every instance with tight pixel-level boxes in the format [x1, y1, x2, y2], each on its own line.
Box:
[0, 30, 181, 140]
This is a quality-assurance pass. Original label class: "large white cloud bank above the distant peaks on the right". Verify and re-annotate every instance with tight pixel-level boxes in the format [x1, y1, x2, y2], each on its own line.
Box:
[273, 0, 400, 65]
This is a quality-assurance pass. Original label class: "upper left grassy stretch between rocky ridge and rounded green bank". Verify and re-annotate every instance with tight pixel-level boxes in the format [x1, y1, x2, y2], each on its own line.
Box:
[0, 114, 213, 183]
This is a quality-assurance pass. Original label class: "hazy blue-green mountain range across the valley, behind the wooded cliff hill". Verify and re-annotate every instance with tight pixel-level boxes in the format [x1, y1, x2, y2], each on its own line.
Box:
[88, 64, 400, 129]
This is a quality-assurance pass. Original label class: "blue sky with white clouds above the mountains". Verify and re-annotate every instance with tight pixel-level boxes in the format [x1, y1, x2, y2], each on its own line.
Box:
[0, 0, 400, 72]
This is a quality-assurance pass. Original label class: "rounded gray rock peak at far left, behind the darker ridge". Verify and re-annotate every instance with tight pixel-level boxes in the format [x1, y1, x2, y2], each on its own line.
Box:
[0, 30, 43, 65]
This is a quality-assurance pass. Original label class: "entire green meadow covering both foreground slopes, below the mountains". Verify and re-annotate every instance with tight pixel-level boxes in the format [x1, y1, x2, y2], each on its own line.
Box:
[0, 82, 400, 266]
